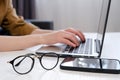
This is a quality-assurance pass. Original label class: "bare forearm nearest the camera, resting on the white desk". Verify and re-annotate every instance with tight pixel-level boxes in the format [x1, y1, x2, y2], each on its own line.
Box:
[0, 35, 42, 51]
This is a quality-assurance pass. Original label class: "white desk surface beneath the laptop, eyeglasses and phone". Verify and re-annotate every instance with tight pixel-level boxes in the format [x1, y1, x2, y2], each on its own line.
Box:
[0, 33, 120, 80]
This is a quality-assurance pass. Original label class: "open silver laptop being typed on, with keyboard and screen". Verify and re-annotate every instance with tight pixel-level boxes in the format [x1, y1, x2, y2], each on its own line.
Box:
[36, 0, 111, 58]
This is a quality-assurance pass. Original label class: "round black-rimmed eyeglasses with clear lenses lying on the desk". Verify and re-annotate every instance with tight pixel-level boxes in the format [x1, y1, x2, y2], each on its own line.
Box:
[8, 53, 59, 74]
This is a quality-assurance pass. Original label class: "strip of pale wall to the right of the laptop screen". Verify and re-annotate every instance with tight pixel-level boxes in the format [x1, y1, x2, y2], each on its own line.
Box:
[107, 0, 120, 32]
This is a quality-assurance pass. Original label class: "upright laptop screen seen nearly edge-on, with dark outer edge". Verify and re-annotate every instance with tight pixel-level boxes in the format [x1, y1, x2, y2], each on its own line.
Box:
[97, 0, 111, 56]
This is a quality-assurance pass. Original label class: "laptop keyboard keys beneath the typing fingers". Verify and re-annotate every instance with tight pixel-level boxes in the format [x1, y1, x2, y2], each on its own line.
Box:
[63, 39, 92, 54]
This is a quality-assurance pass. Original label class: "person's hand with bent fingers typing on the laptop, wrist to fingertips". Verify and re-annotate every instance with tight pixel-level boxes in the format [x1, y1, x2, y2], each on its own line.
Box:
[38, 28, 85, 47]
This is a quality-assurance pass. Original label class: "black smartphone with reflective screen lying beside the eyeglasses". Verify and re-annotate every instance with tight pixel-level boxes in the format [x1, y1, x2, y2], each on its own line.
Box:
[60, 57, 120, 74]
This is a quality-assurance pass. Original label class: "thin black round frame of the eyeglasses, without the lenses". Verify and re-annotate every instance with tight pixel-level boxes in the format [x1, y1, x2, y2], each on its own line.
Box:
[7, 52, 59, 75]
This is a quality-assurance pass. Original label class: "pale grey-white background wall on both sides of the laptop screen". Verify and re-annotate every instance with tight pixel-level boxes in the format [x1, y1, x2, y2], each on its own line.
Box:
[36, 0, 120, 32]
